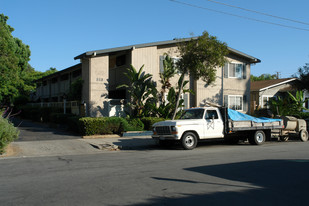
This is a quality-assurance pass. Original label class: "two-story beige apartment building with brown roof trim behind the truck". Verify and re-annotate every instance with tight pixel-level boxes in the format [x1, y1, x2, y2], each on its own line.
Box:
[37, 39, 260, 116]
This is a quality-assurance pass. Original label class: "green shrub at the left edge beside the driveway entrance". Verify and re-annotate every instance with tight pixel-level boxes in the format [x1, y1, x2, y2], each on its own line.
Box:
[0, 114, 19, 154]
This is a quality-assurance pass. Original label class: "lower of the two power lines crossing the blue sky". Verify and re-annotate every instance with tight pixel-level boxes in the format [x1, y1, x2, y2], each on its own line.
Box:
[169, 0, 309, 31]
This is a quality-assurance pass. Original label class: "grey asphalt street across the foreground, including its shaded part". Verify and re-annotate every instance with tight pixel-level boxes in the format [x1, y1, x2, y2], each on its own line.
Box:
[0, 118, 309, 206]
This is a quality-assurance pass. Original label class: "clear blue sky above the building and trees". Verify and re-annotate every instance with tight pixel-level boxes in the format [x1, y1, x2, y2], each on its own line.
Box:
[0, 0, 309, 78]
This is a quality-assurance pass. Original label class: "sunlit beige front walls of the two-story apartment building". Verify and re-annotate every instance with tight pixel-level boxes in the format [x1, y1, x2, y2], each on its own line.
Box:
[78, 45, 254, 116]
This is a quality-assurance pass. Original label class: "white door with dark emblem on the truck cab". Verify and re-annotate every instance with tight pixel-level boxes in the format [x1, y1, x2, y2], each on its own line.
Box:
[204, 109, 224, 138]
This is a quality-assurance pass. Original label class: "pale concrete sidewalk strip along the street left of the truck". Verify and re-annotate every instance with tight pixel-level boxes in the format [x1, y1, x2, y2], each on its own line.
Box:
[0, 136, 156, 158]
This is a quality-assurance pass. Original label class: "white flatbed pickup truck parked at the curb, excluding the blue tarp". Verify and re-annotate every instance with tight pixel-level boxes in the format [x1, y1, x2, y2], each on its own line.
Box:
[152, 107, 284, 150]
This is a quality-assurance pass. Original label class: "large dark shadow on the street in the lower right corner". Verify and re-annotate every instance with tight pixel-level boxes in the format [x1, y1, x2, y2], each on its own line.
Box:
[129, 160, 309, 206]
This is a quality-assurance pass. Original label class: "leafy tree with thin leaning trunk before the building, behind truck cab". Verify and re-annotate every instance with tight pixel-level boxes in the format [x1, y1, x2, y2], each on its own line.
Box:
[173, 31, 229, 119]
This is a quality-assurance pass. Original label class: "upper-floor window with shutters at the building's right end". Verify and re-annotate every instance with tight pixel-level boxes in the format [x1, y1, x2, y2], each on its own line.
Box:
[224, 63, 246, 79]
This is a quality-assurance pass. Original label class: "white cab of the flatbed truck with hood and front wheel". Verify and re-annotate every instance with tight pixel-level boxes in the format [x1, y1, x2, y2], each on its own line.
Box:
[152, 107, 224, 149]
